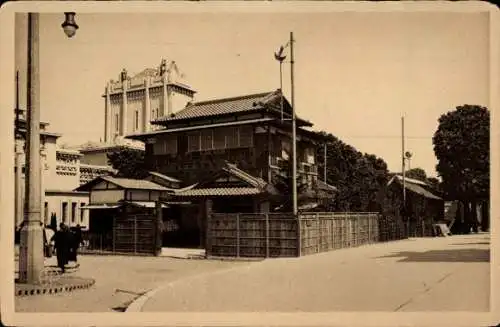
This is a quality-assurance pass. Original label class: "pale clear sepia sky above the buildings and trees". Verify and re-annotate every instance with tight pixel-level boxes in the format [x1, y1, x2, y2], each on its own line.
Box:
[16, 11, 490, 176]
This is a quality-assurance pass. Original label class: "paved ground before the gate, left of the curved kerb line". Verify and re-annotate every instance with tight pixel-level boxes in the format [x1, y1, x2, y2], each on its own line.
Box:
[15, 255, 249, 312]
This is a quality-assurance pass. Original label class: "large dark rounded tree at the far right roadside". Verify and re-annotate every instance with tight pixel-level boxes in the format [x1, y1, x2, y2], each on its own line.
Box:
[433, 105, 490, 233]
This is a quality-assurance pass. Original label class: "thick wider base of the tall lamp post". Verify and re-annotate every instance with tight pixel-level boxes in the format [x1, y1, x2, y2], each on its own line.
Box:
[19, 221, 45, 284]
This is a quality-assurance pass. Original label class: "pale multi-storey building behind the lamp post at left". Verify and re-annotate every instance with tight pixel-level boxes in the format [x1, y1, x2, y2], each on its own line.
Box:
[14, 112, 112, 227]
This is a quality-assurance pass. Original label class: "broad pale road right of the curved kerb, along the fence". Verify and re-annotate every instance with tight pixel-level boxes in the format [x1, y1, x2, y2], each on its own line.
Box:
[142, 234, 490, 312]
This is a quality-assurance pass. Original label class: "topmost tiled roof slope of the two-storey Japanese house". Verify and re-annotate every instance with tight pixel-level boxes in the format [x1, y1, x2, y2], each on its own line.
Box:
[157, 91, 279, 121]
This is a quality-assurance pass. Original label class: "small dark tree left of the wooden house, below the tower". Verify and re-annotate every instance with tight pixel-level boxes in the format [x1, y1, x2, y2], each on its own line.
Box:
[107, 147, 148, 179]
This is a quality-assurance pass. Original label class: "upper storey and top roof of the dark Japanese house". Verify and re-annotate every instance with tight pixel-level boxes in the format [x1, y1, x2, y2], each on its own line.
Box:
[127, 90, 326, 193]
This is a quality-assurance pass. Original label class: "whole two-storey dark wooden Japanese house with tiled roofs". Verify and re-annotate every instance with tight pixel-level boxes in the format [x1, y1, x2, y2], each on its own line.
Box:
[123, 90, 336, 245]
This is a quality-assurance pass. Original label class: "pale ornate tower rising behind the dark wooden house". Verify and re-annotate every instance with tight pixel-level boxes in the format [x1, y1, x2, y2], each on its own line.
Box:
[103, 59, 196, 143]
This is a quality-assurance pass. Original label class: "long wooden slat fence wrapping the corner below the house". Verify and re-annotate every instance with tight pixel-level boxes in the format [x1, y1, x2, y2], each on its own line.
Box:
[206, 212, 406, 258]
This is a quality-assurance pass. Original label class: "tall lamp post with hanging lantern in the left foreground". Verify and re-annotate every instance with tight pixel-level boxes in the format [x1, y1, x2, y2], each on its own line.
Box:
[19, 12, 78, 284]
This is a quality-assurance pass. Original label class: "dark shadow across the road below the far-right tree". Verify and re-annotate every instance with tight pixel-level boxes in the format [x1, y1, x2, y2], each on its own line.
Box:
[379, 249, 490, 262]
